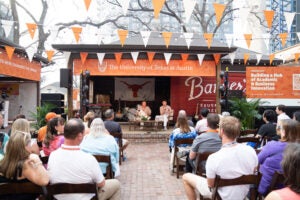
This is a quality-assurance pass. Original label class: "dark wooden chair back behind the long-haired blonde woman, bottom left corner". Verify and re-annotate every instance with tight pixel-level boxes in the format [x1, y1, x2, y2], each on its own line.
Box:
[0, 182, 46, 200]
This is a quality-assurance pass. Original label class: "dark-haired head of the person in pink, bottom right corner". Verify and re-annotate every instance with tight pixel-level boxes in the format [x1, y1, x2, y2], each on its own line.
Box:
[281, 143, 300, 194]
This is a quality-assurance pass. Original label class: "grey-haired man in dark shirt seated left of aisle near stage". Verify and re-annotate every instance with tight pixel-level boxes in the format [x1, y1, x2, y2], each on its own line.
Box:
[104, 109, 129, 155]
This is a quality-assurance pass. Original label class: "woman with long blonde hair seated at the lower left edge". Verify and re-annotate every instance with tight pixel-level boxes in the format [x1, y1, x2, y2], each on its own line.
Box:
[0, 131, 49, 199]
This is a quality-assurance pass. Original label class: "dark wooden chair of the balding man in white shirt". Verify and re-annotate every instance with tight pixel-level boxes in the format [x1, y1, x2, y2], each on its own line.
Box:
[47, 183, 98, 200]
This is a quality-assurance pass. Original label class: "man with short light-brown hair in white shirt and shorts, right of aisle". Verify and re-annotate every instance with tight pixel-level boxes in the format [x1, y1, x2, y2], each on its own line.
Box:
[182, 116, 258, 200]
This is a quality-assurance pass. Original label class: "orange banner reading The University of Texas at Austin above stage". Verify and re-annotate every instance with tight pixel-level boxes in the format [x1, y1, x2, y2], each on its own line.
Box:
[74, 59, 216, 76]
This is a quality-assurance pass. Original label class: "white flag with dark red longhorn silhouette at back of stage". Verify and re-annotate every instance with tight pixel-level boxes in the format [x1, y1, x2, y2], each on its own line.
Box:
[115, 78, 155, 101]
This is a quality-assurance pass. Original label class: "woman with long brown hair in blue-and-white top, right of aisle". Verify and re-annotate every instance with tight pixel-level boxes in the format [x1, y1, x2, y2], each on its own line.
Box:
[169, 110, 197, 169]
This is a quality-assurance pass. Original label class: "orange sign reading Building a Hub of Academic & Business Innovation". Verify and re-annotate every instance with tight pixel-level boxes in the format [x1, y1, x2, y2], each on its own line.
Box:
[246, 66, 300, 99]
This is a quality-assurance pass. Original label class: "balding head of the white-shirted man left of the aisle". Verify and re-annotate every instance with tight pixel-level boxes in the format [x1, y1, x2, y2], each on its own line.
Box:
[64, 118, 84, 140]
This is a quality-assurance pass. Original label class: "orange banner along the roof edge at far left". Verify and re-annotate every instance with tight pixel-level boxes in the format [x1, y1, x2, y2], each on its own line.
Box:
[0, 50, 41, 81]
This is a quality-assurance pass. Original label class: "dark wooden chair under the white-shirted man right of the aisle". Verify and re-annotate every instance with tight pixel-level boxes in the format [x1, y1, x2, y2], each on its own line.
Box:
[212, 173, 261, 200]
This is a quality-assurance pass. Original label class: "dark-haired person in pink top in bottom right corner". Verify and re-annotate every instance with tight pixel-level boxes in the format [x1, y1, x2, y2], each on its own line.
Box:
[265, 143, 300, 200]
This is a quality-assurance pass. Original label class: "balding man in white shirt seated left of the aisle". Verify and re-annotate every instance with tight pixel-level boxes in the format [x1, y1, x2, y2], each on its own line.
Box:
[48, 118, 121, 200]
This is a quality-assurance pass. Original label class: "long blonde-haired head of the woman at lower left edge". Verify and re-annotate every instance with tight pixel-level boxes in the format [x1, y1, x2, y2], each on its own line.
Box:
[0, 131, 31, 179]
